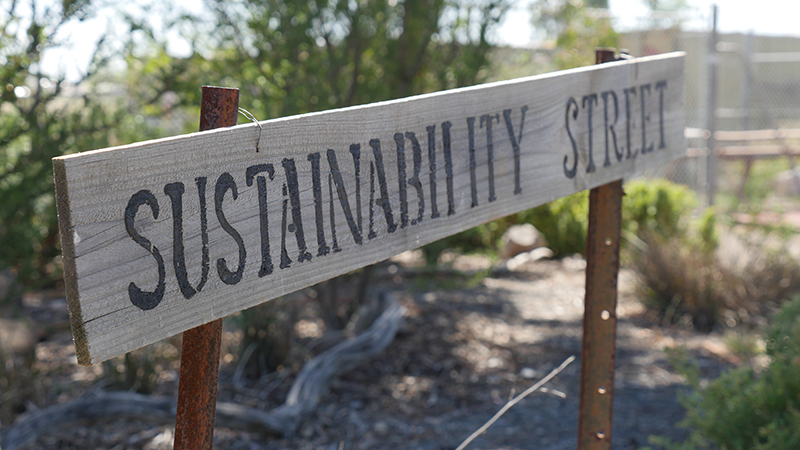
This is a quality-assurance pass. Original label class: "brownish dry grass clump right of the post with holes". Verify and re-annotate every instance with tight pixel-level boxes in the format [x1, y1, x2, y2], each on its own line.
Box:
[631, 221, 800, 331]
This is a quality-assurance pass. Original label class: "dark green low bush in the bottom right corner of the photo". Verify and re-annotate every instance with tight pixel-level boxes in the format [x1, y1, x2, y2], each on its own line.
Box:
[653, 297, 800, 450]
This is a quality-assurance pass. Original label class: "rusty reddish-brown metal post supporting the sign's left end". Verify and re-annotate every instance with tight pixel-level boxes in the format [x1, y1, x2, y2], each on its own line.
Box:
[174, 86, 239, 450]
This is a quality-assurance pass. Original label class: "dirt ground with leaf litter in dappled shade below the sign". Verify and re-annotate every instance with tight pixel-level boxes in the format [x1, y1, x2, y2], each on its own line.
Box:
[4, 258, 728, 450]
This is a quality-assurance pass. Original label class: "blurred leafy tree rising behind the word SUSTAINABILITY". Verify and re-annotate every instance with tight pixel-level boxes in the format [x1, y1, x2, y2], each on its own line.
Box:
[170, 0, 507, 120]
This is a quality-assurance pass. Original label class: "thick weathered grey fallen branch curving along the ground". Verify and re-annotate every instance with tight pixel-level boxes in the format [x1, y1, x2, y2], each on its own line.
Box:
[0, 294, 405, 450]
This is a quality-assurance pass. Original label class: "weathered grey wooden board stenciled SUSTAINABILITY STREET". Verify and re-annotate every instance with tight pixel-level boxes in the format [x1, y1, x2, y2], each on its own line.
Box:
[53, 54, 685, 364]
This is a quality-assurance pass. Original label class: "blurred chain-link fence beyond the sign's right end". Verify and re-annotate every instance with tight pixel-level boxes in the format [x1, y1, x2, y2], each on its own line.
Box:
[620, 10, 800, 206]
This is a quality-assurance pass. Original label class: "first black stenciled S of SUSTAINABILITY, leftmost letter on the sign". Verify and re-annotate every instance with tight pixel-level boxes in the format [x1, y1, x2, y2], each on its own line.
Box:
[125, 190, 166, 311]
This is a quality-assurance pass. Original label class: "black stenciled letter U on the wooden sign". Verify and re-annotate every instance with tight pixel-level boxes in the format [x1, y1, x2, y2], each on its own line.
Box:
[164, 177, 208, 299]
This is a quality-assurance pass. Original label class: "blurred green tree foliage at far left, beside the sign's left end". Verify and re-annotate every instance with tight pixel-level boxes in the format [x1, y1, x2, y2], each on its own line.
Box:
[0, 0, 142, 285]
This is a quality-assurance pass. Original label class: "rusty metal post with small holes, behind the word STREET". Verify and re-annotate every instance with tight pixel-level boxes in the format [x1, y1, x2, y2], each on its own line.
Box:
[578, 49, 623, 450]
